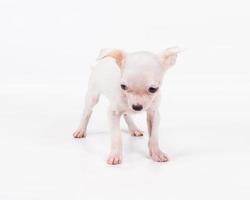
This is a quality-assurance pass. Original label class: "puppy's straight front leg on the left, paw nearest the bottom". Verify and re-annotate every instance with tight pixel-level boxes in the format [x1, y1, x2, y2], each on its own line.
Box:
[107, 110, 122, 165]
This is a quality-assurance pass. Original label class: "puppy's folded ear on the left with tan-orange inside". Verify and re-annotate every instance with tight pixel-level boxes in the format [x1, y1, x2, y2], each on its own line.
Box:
[97, 49, 126, 68]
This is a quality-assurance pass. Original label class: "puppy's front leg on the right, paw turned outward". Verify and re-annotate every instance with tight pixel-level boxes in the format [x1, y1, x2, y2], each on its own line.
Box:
[147, 109, 168, 162]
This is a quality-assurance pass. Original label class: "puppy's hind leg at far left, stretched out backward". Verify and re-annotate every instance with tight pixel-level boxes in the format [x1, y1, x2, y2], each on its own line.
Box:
[73, 87, 100, 138]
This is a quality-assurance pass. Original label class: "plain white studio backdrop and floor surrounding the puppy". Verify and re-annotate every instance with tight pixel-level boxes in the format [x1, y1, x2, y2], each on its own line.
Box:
[0, 0, 250, 200]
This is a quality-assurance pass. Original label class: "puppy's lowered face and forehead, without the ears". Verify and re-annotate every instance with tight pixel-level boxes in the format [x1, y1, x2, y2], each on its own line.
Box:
[120, 52, 164, 111]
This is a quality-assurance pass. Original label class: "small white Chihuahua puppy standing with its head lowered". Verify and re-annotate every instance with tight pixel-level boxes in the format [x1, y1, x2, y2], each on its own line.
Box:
[73, 48, 178, 165]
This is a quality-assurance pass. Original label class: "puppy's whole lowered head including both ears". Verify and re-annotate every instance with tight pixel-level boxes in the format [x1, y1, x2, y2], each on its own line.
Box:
[97, 48, 177, 112]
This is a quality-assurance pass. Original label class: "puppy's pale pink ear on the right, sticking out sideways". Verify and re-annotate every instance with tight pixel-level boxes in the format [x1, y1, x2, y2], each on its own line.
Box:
[159, 47, 181, 69]
